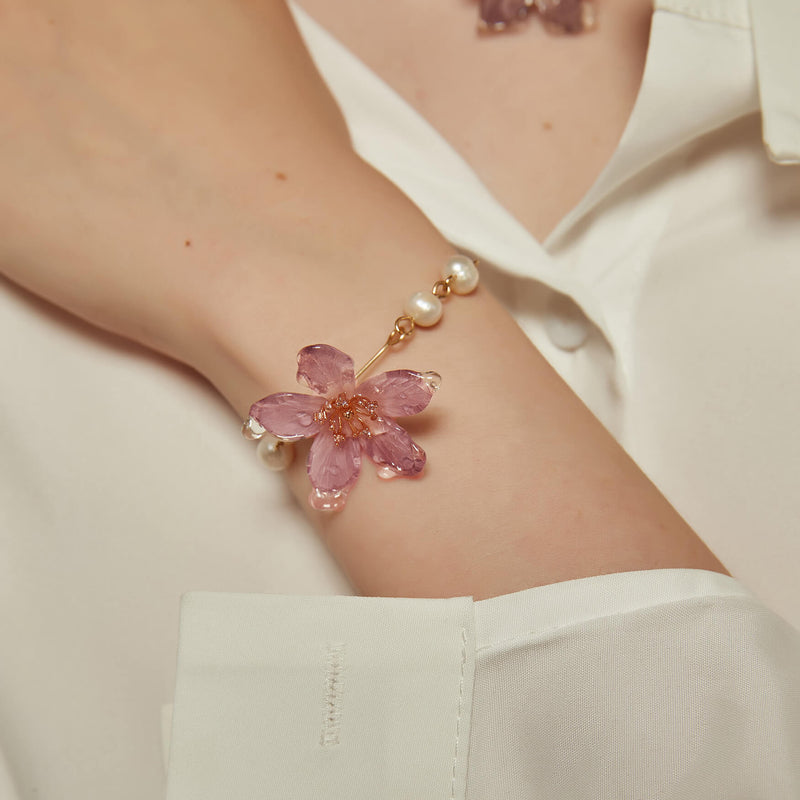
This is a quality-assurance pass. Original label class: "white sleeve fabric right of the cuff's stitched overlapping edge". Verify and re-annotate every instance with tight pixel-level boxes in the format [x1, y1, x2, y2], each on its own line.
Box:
[468, 570, 800, 800]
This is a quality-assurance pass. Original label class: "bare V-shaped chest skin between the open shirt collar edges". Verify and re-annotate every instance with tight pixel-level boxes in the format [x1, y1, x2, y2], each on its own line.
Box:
[301, 0, 651, 240]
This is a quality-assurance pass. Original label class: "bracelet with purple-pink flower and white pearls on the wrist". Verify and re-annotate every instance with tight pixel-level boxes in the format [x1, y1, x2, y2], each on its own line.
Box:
[242, 255, 479, 511]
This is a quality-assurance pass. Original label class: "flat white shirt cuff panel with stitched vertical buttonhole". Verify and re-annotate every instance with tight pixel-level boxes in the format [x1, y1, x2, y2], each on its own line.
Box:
[167, 593, 475, 800]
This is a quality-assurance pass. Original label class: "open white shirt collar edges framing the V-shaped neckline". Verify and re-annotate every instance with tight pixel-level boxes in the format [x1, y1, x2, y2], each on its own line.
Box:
[290, 0, 800, 260]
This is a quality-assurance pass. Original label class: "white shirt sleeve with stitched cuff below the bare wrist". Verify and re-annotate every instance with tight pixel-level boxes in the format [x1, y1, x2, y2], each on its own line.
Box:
[162, 570, 800, 800]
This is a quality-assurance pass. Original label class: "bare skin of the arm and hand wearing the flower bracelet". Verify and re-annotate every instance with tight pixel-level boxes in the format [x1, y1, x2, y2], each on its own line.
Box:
[0, 0, 725, 599]
